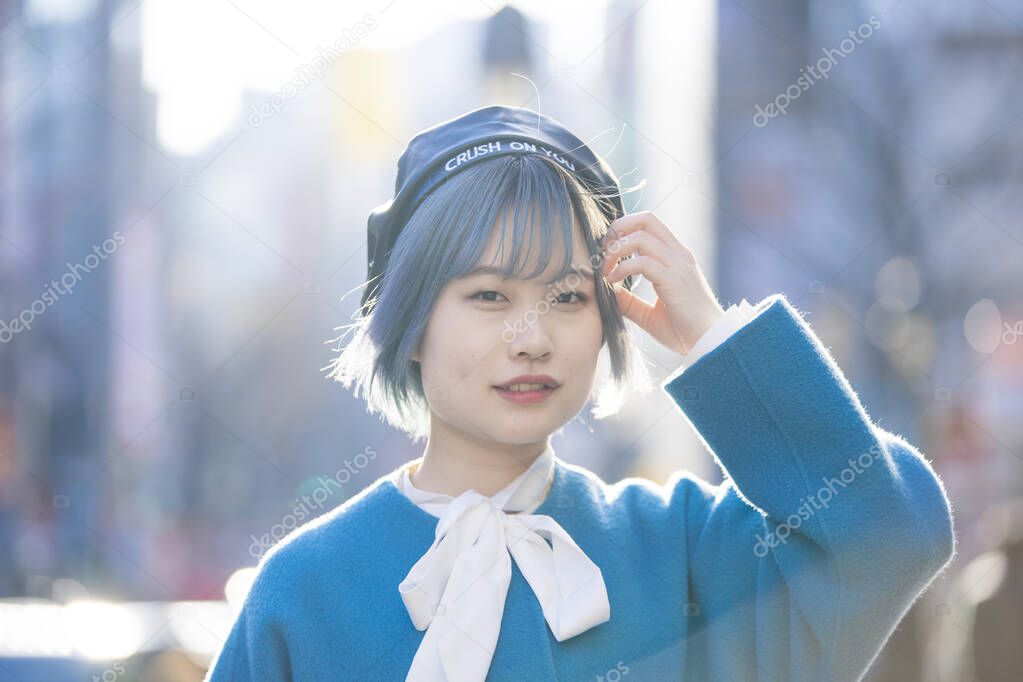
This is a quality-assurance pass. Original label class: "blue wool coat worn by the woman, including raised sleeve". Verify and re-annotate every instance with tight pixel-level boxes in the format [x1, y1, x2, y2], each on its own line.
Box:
[209, 294, 954, 682]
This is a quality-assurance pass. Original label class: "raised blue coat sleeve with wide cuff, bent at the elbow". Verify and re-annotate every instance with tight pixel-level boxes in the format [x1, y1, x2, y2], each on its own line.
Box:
[663, 294, 954, 680]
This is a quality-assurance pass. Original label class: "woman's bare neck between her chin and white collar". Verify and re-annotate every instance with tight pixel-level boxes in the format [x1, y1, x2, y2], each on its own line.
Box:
[409, 430, 548, 497]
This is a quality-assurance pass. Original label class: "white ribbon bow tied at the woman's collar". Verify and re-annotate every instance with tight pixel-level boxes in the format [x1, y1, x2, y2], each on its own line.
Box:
[398, 490, 611, 682]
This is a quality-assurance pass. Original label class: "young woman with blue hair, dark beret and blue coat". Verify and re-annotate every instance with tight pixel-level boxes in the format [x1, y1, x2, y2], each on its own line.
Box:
[209, 106, 953, 682]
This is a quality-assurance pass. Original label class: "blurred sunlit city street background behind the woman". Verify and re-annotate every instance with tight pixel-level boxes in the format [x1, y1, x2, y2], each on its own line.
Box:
[0, 0, 1023, 682]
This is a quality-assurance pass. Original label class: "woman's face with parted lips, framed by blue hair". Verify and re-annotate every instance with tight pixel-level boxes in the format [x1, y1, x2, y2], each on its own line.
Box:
[413, 215, 603, 445]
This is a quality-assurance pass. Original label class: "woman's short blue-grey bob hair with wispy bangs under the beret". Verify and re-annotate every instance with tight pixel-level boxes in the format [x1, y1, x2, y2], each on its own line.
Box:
[327, 154, 650, 441]
